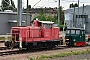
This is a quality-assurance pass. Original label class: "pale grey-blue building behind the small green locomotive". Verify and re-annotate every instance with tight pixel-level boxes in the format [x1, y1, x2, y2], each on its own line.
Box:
[64, 5, 90, 33]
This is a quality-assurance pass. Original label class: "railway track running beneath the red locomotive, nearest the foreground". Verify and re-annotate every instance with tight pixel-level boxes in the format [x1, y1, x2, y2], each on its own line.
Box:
[0, 46, 88, 56]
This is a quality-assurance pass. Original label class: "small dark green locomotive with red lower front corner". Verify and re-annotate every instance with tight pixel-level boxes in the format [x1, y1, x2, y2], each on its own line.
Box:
[65, 28, 86, 46]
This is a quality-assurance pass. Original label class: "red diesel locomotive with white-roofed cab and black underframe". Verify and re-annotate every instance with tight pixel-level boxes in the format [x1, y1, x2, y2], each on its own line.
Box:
[5, 20, 60, 49]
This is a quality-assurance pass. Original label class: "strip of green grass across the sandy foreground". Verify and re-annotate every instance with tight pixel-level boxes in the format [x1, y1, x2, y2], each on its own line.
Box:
[28, 49, 90, 60]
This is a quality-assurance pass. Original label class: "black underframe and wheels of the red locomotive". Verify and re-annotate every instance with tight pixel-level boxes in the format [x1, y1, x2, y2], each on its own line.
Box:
[5, 40, 62, 49]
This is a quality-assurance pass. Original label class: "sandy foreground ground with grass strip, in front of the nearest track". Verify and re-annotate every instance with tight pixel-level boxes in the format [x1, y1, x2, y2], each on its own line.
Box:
[0, 46, 90, 60]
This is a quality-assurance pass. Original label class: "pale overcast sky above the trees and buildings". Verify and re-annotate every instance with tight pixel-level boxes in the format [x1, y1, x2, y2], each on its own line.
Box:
[0, 0, 90, 9]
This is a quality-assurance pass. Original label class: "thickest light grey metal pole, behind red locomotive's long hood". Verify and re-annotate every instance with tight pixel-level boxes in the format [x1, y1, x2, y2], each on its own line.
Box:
[18, 0, 22, 26]
